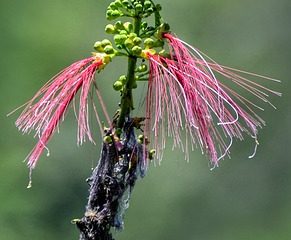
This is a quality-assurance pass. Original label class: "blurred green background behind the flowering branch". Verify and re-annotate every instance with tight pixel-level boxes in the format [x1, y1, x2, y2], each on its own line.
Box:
[0, 0, 291, 240]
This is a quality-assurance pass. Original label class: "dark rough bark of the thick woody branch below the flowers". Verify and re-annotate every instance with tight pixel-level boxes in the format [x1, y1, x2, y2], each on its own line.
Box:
[75, 119, 145, 240]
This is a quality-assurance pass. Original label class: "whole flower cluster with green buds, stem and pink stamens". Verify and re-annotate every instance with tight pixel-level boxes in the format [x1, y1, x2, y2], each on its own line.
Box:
[16, 0, 280, 171]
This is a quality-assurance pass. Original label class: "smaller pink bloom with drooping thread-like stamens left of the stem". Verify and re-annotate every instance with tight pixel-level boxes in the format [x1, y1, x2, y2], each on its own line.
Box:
[16, 54, 109, 169]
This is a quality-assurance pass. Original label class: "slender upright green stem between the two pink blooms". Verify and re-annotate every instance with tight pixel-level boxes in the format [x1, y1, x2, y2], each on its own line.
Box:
[117, 16, 141, 128]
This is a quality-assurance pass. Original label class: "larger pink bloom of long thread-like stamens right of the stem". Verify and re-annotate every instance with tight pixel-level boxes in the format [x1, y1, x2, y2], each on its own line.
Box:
[146, 33, 280, 167]
